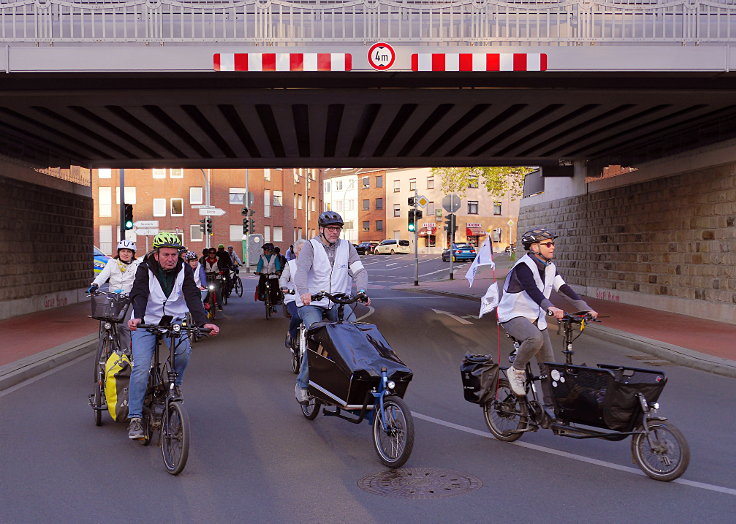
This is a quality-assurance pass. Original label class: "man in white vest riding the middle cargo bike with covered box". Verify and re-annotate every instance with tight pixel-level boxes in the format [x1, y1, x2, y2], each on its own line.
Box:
[294, 211, 370, 403]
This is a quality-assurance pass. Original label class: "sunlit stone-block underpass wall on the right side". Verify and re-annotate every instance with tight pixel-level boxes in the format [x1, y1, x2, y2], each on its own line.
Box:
[519, 164, 736, 323]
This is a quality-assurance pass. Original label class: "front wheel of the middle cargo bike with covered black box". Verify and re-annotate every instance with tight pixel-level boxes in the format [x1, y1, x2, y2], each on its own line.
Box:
[373, 395, 414, 468]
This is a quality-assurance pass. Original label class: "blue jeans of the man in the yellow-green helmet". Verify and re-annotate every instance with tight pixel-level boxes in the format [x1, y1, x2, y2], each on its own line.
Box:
[128, 329, 192, 418]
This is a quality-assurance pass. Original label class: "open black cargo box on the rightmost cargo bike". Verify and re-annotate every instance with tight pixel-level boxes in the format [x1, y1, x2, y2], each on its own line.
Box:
[545, 362, 667, 432]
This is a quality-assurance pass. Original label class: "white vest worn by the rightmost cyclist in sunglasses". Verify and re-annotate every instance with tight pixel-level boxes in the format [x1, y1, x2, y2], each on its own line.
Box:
[498, 253, 565, 329]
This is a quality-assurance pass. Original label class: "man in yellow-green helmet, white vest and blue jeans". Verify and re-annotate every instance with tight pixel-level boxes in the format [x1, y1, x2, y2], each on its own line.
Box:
[128, 233, 220, 440]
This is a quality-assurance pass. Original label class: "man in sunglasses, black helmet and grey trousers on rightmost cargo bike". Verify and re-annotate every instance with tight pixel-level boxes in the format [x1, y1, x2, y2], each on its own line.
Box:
[498, 228, 598, 398]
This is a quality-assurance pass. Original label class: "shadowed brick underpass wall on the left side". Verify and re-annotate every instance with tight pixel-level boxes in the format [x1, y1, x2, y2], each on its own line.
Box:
[0, 172, 94, 312]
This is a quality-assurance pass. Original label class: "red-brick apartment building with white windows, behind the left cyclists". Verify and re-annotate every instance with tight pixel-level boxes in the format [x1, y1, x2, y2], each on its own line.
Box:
[91, 168, 322, 254]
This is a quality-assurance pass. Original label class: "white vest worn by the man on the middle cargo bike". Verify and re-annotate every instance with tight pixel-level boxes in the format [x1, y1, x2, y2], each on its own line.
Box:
[296, 238, 352, 308]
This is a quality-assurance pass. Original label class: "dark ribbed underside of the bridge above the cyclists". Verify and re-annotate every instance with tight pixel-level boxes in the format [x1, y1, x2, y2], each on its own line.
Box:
[0, 72, 736, 168]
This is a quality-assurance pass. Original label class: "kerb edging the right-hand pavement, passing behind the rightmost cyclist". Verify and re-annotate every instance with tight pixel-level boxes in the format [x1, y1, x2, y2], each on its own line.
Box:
[392, 287, 736, 378]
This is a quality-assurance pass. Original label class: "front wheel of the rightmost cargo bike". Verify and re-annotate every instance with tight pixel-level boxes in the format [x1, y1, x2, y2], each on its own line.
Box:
[631, 422, 690, 482]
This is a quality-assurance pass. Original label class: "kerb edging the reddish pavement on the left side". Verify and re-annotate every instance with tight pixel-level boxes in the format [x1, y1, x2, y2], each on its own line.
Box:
[0, 333, 97, 391]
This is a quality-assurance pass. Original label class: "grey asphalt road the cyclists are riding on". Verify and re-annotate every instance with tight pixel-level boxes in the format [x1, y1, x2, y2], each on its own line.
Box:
[0, 256, 736, 523]
